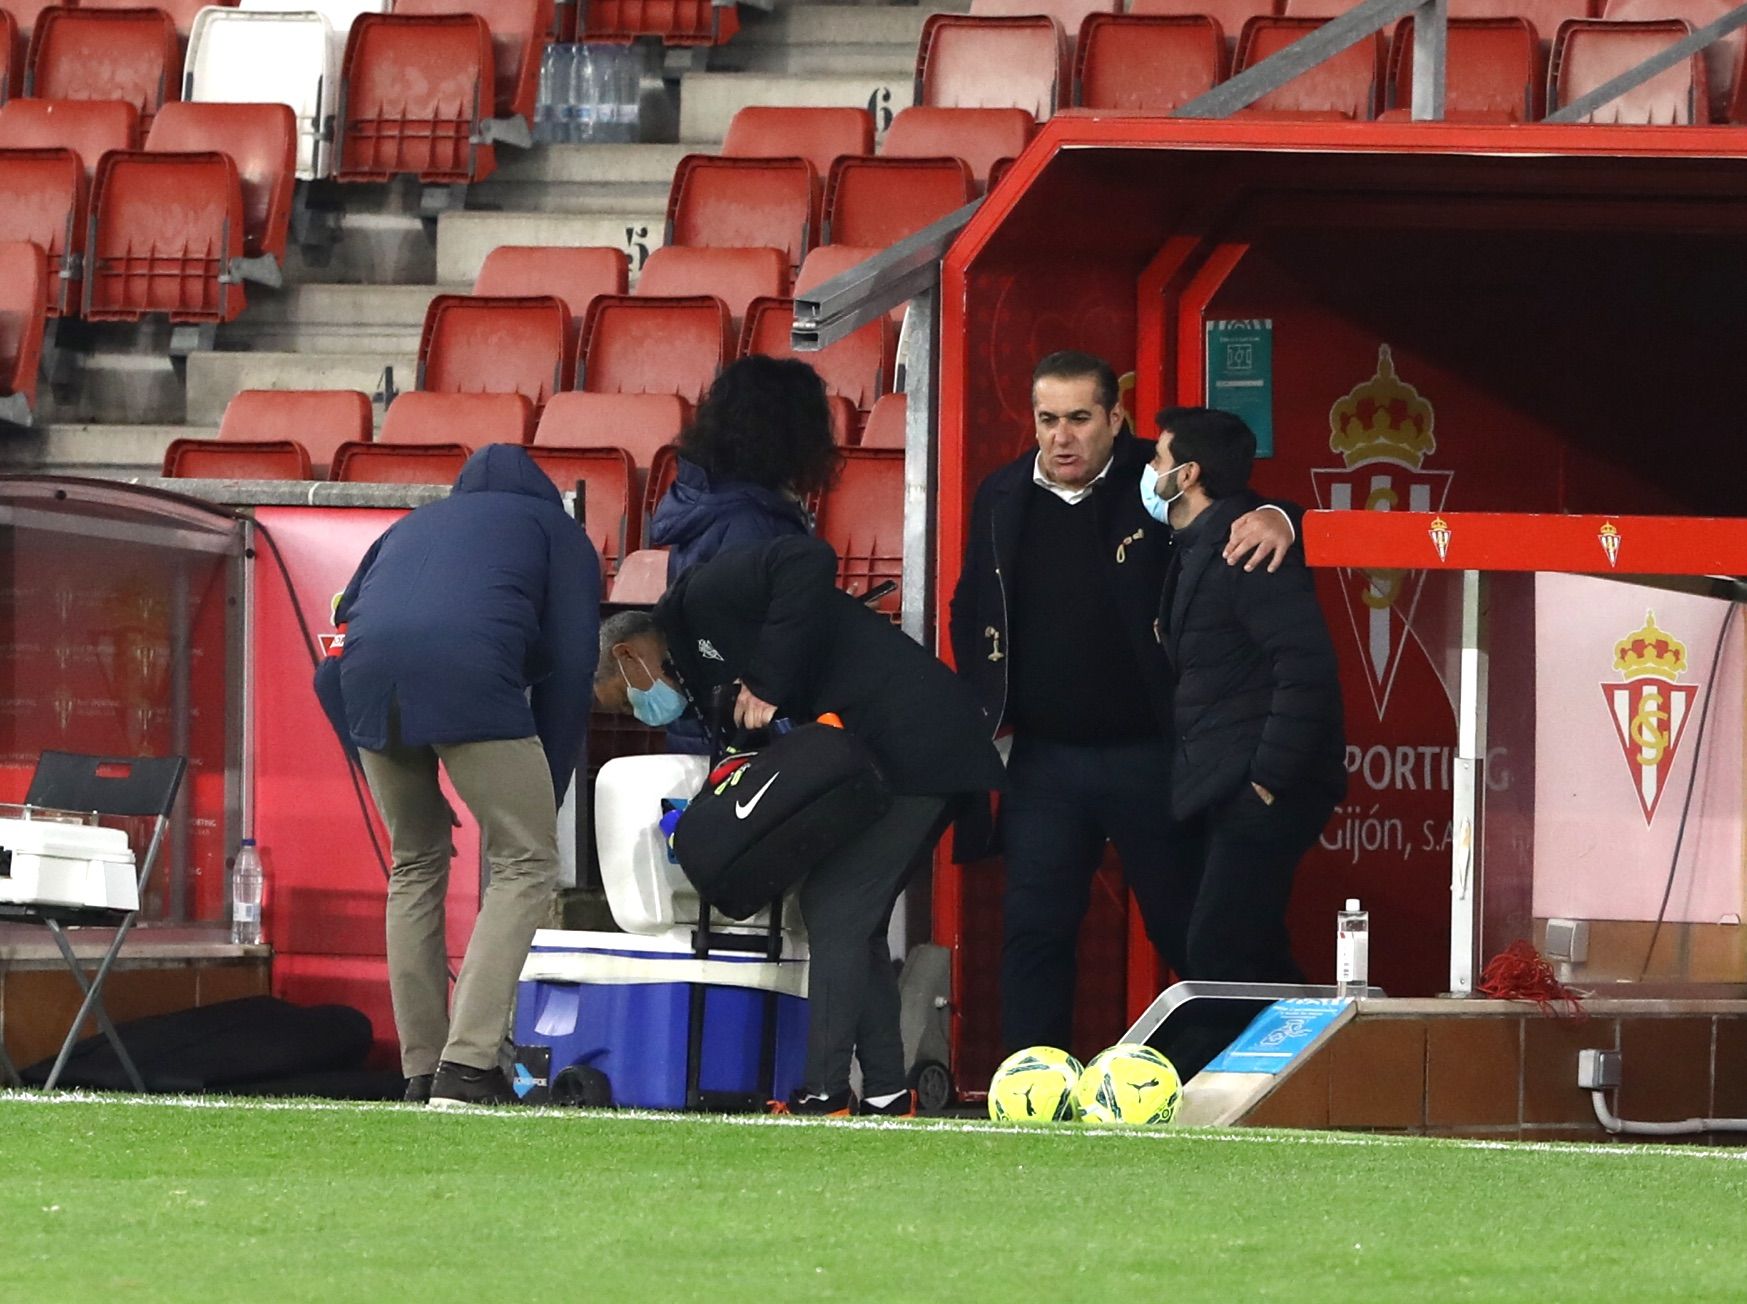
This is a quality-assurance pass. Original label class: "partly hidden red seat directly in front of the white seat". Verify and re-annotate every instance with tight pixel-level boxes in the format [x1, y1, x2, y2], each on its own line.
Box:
[145, 101, 297, 262]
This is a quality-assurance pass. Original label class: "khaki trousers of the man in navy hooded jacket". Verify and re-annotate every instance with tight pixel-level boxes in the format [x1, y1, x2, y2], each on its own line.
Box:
[360, 738, 557, 1077]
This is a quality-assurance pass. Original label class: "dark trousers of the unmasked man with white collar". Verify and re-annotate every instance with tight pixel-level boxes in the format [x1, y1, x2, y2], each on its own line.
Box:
[1001, 736, 1183, 1052]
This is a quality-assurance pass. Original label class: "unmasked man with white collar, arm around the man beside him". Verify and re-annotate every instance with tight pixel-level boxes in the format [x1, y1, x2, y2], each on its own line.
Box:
[952, 353, 1295, 1051]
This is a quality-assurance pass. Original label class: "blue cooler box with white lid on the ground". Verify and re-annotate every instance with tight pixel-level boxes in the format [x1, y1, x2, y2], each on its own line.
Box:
[515, 930, 807, 1110]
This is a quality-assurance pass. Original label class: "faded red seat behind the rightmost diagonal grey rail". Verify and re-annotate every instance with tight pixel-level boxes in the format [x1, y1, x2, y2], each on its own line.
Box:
[1546, 17, 1710, 126]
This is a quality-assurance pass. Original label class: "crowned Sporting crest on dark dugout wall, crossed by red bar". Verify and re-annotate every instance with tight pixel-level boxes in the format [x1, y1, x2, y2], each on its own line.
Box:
[1310, 344, 1454, 718]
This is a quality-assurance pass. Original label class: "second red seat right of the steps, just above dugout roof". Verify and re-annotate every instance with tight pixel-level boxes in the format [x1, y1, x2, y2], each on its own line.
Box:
[1074, 14, 1226, 112]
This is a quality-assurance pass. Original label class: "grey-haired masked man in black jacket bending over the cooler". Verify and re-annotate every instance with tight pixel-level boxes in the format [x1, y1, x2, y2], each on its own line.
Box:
[594, 537, 1003, 1115]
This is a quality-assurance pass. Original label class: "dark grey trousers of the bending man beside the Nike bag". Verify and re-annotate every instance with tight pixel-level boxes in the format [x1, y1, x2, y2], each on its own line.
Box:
[798, 795, 947, 1096]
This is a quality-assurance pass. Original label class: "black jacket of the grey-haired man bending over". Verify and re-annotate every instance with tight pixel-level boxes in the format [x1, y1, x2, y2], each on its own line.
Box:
[655, 538, 1003, 795]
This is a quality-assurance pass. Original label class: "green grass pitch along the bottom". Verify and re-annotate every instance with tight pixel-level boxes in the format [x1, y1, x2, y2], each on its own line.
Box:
[0, 1094, 1747, 1304]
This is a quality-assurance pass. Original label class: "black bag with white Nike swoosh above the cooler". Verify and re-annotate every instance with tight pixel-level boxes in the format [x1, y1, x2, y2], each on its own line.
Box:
[673, 724, 891, 919]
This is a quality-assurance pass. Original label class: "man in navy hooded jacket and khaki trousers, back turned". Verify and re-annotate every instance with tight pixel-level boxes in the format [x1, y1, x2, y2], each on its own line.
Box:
[316, 444, 601, 1108]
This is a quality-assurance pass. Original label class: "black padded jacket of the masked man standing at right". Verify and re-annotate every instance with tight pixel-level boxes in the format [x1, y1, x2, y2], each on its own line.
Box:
[1158, 493, 1347, 820]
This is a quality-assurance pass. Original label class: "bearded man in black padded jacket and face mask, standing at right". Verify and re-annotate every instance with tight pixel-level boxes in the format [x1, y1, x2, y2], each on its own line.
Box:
[1143, 407, 1347, 1013]
